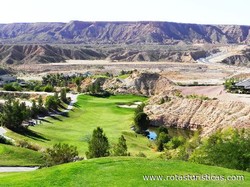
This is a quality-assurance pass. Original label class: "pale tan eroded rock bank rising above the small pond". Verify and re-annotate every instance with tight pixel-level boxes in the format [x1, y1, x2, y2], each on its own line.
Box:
[144, 94, 250, 136]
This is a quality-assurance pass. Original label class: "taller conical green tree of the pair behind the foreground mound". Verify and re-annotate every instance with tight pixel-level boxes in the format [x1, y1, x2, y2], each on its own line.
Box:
[86, 127, 109, 158]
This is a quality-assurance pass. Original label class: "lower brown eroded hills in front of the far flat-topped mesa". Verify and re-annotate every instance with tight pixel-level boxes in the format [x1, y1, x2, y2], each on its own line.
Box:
[0, 44, 216, 65]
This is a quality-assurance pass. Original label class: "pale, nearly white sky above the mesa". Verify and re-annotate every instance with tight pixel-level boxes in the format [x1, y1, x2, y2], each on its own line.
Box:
[0, 0, 250, 25]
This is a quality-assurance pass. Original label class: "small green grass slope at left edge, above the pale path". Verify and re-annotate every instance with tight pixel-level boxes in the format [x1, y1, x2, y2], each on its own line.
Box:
[0, 144, 42, 166]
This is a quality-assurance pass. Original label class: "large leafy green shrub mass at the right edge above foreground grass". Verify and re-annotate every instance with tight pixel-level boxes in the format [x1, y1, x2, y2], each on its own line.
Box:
[189, 129, 250, 171]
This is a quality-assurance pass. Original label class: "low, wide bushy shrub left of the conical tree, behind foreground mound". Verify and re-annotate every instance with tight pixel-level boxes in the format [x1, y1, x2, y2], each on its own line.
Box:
[43, 143, 78, 166]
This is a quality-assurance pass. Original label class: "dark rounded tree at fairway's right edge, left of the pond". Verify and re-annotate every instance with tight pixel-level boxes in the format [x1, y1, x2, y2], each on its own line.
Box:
[134, 112, 150, 133]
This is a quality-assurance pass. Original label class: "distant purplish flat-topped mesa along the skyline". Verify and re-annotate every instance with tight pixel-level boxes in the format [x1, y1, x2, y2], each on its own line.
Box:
[0, 21, 250, 44]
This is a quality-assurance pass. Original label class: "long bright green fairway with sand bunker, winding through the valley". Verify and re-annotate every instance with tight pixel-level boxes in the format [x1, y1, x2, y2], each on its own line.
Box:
[7, 95, 157, 157]
